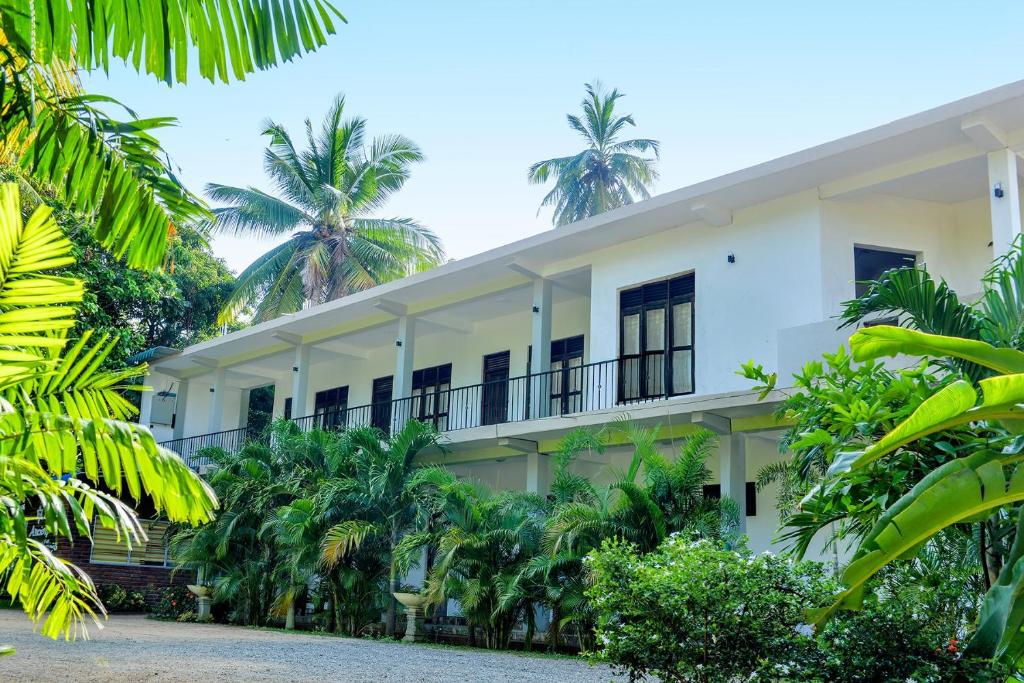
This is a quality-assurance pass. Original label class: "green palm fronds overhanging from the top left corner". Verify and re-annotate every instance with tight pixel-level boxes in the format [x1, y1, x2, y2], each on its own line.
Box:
[0, 0, 344, 267]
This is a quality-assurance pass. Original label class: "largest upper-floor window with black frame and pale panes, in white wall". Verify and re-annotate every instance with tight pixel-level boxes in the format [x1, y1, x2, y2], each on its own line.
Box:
[618, 273, 694, 401]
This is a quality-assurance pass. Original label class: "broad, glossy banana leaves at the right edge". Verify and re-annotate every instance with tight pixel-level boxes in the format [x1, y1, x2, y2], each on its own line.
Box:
[805, 326, 1024, 664]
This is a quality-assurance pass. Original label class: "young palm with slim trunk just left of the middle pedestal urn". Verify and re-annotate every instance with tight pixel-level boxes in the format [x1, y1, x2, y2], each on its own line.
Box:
[323, 420, 438, 635]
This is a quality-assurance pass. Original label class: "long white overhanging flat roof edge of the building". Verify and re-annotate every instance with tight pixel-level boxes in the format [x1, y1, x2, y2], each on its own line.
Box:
[154, 80, 1024, 374]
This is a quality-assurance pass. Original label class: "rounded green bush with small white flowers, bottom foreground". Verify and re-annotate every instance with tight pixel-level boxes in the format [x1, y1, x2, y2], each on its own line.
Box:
[588, 536, 829, 681]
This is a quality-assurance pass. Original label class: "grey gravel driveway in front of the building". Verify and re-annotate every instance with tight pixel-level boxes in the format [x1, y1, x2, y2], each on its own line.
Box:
[0, 609, 612, 683]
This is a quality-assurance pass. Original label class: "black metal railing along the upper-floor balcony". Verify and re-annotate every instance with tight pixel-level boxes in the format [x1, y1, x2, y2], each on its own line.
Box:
[162, 358, 684, 469]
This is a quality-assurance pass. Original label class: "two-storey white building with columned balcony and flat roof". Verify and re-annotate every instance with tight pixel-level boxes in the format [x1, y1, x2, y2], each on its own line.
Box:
[140, 81, 1024, 550]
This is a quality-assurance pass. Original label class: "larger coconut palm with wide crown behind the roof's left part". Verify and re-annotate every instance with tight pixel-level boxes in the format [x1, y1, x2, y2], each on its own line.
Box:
[207, 95, 444, 321]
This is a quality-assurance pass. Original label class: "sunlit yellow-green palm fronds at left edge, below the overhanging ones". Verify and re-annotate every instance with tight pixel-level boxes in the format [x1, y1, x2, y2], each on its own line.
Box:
[0, 183, 217, 638]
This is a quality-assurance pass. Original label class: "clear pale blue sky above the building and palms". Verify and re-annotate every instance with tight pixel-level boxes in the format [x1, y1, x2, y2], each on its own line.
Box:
[85, 0, 1024, 270]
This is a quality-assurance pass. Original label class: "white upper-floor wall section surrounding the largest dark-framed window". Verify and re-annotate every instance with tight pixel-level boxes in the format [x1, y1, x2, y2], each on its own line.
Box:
[590, 193, 821, 394]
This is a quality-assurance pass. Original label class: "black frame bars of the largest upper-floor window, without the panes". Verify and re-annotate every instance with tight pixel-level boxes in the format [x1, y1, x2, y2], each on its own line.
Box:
[617, 272, 696, 403]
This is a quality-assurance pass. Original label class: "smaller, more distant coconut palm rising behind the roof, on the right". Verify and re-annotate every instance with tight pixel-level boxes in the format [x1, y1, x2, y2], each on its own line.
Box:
[529, 82, 658, 225]
